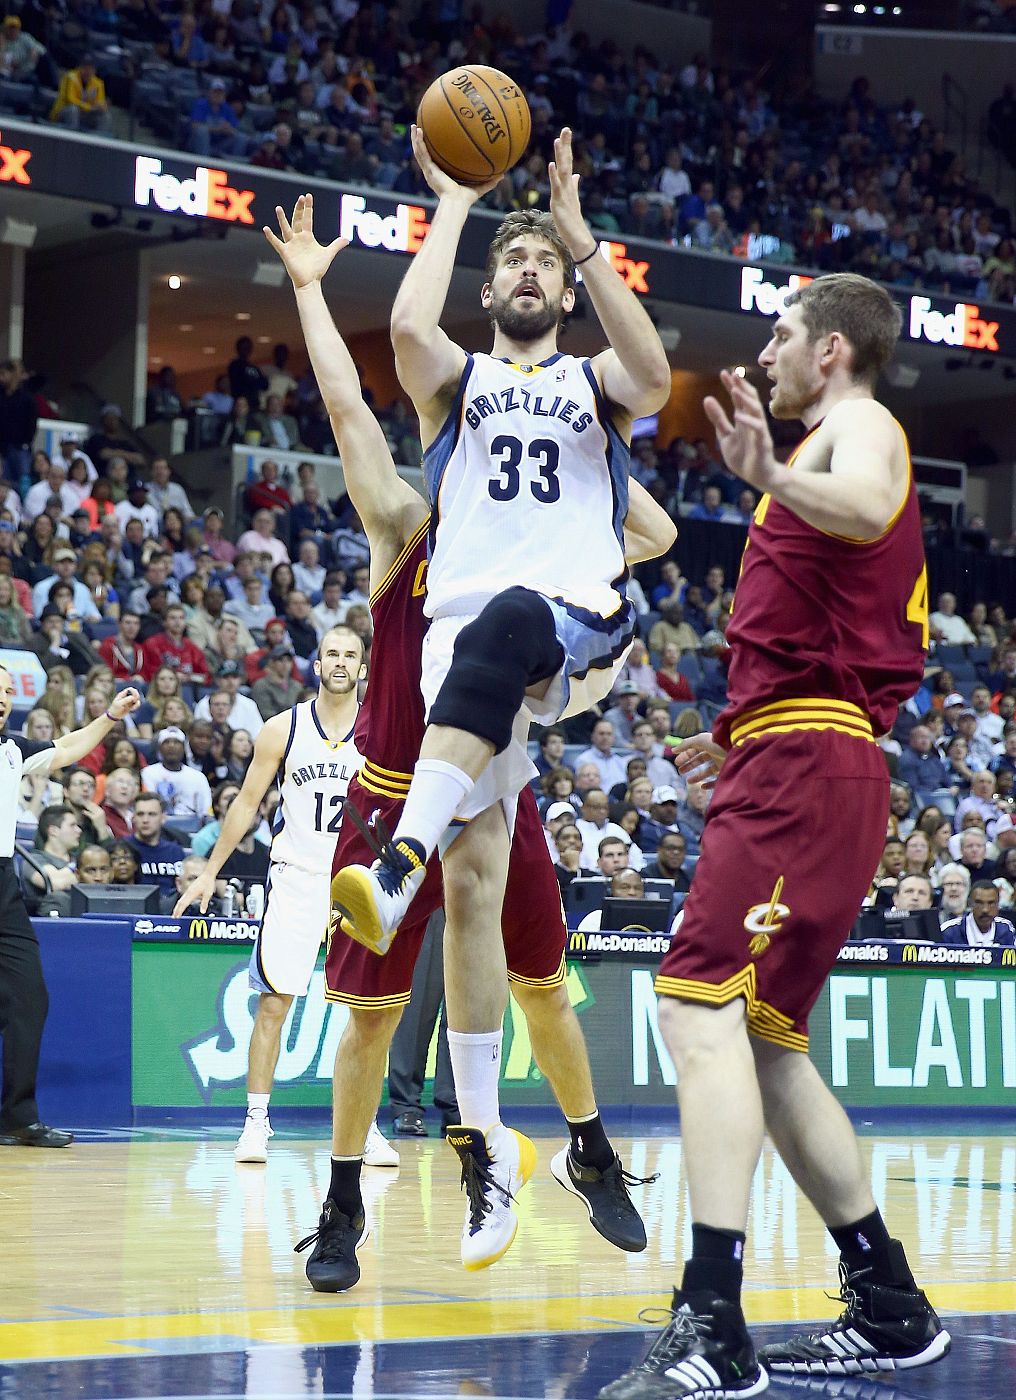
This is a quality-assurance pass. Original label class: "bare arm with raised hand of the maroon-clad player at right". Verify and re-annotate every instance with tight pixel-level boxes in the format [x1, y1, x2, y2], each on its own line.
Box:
[704, 371, 905, 540]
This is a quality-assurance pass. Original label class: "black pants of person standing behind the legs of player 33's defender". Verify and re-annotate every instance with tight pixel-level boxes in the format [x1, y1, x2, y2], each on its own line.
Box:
[388, 911, 458, 1117]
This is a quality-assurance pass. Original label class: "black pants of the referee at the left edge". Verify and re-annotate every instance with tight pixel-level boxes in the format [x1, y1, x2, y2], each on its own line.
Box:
[0, 857, 49, 1131]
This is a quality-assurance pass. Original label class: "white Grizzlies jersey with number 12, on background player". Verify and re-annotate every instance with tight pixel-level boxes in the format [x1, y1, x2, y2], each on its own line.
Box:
[271, 700, 362, 875]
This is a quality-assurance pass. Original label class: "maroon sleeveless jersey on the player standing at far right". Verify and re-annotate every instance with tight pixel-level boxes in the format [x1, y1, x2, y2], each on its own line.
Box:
[715, 430, 928, 745]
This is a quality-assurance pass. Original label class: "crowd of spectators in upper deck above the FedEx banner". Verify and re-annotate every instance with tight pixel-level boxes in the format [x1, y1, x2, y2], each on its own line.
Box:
[0, 0, 1016, 302]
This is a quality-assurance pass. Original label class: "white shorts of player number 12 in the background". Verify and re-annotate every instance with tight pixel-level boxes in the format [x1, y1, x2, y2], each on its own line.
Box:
[249, 861, 332, 997]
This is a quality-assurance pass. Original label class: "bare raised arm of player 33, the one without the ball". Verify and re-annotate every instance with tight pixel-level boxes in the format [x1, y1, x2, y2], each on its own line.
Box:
[547, 126, 670, 419]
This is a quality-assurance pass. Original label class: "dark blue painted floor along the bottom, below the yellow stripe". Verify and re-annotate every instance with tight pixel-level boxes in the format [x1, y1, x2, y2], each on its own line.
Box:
[0, 1313, 1016, 1400]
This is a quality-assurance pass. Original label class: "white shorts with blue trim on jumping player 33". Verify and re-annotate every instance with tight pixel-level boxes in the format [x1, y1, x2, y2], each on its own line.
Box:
[421, 598, 634, 832]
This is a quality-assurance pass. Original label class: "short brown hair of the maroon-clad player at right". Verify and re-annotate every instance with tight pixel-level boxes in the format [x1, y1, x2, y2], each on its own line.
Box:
[786, 272, 903, 384]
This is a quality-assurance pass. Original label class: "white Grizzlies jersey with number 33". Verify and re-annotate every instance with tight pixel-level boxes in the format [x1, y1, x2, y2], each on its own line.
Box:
[424, 354, 628, 617]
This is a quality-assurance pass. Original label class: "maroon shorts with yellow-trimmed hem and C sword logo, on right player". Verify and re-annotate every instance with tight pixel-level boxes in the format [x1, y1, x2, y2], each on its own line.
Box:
[656, 707, 889, 1051]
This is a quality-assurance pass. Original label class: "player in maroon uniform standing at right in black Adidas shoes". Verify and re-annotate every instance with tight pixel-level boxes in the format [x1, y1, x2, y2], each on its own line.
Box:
[600, 274, 949, 1400]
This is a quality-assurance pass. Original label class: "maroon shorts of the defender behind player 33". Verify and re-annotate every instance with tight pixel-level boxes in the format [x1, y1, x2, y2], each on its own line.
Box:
[325, 769, 567, 1009]
